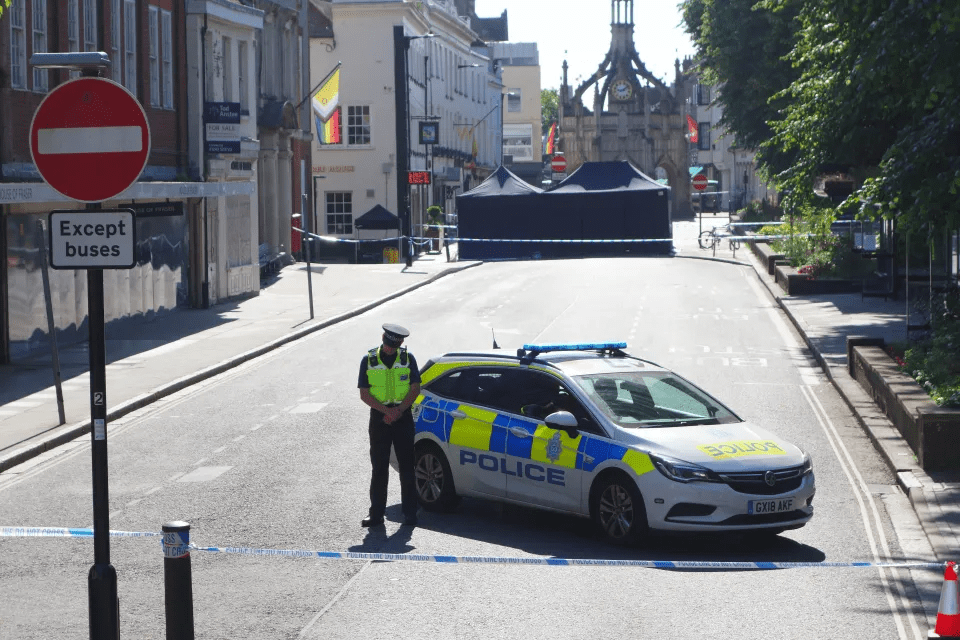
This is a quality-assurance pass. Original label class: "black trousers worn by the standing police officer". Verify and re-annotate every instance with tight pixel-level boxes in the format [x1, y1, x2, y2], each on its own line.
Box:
[369, 409, 417, 520]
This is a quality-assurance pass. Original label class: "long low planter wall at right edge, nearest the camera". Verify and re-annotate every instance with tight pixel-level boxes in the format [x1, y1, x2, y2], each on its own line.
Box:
[849, 346, 960, 471]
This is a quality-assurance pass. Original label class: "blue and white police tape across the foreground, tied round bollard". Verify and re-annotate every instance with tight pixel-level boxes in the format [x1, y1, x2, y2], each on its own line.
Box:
[0, 527, 947, 570]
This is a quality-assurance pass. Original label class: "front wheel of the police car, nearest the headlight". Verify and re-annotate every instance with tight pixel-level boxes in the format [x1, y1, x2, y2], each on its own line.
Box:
[591, 473, 647, 545]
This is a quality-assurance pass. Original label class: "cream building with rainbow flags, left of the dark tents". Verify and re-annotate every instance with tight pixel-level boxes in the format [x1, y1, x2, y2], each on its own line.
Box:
[310, 0, 502, 261]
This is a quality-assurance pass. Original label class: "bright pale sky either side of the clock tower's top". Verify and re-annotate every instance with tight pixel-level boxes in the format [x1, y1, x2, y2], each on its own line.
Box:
[476, 0, 694, 89]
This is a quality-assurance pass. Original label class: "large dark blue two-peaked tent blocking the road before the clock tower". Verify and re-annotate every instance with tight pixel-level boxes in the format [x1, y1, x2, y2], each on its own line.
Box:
[457, 162, 673, 260]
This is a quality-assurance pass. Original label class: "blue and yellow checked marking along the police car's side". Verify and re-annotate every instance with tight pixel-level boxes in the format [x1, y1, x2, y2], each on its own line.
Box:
[414, 394, 654, 485]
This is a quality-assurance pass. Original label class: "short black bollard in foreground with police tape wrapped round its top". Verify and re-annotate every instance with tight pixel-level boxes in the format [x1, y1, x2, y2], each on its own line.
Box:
[162, 521, 194, 640]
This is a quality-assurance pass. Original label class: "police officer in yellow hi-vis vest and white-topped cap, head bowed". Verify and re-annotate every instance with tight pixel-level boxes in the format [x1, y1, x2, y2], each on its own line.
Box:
[357, 324, 420, 527]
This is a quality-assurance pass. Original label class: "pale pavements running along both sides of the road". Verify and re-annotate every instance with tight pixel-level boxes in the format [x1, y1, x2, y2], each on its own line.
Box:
[0, 221, 960, 561]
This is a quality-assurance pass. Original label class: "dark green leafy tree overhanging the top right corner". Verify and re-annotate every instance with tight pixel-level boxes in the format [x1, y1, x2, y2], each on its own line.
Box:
[761, 0, 960, 229]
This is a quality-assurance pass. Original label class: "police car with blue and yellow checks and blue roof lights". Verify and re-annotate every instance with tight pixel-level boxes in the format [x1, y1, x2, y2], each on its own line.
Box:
[402, 342, 815, 544]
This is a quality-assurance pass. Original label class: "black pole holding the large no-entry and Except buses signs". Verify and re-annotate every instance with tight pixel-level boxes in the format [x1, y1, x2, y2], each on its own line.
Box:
[87, 203, 120, 640]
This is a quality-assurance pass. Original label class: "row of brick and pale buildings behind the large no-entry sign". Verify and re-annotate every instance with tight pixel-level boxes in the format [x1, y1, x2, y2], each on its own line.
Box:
[0, 0, 311, 362]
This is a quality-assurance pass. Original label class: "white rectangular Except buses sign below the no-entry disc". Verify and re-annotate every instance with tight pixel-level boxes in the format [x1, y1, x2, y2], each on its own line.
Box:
[48, 209, 137, 269]
